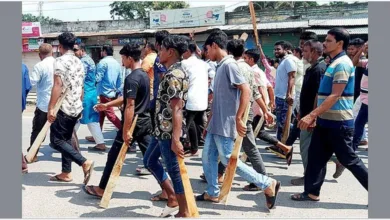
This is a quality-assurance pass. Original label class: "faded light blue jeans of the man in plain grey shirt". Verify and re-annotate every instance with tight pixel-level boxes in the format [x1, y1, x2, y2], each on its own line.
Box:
[202, 133, 272, 197]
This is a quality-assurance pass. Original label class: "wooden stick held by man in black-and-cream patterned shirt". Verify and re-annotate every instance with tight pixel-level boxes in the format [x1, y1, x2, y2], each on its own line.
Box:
[177, 157, 199, 218]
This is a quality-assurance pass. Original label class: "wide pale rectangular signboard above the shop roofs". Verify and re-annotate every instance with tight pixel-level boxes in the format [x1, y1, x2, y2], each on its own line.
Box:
[150, 6, 225, 28]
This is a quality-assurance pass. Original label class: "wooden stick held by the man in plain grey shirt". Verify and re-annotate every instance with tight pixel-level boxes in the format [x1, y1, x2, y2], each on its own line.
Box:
[219, 105, 250, 204]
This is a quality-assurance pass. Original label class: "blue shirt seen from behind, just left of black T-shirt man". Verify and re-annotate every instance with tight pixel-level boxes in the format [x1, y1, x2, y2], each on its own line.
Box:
[96, 56, 123, 98]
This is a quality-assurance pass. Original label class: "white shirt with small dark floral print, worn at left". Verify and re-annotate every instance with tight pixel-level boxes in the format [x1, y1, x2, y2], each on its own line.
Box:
[54, 52, 85, 117]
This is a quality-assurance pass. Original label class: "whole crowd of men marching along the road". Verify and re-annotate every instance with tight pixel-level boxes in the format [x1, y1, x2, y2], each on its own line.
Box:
[22, 28, 368, 217]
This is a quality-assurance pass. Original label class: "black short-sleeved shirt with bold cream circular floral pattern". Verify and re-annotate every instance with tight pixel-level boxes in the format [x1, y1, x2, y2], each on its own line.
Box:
[154, 62, 189, 140]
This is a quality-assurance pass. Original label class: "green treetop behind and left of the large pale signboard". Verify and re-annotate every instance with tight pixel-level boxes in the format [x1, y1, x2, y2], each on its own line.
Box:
[110, 1, 189, 19]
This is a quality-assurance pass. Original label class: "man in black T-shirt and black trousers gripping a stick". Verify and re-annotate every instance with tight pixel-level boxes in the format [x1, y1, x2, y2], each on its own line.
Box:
[84, 44, 152, 197]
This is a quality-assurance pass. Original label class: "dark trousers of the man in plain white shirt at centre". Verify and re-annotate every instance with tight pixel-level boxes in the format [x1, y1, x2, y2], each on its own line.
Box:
[185, 110, 205, 151]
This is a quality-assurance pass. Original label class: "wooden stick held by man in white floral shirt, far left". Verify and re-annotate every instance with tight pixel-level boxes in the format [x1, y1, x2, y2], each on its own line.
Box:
[25, 88, 68, 163]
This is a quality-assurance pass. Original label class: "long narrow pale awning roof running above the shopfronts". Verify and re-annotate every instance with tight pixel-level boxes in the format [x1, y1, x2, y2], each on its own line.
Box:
[42, 18, 368, 38]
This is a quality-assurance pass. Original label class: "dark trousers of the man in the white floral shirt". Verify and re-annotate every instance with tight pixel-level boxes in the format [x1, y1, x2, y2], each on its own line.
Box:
[50, 110, 87, 173]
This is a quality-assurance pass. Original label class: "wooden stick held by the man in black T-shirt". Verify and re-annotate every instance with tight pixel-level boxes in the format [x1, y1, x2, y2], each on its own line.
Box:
[99, 115, 138, 209]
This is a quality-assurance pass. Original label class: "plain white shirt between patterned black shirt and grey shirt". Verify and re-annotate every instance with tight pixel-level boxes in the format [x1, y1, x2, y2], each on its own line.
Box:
[182, 55, 212, 111]
